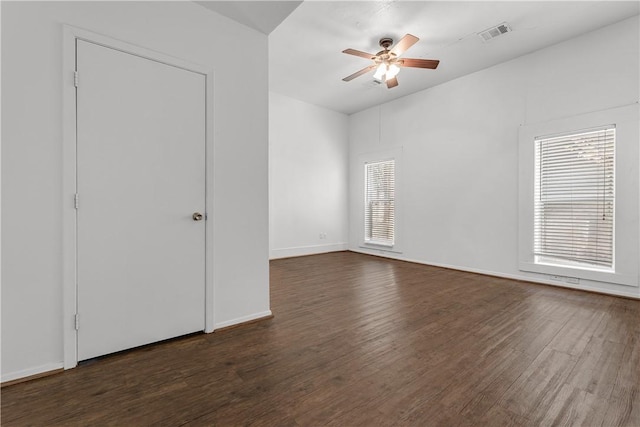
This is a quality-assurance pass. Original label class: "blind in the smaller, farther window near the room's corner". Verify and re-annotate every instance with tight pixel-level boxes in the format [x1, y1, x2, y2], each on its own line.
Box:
[364, 160, 395, 246]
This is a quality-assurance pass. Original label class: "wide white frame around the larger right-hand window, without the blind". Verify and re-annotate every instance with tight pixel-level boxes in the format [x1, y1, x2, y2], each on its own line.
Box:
[518, 104, 640, 287]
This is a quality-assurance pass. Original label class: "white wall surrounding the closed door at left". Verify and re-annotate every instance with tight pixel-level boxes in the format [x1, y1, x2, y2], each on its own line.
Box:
[1, 1, 269, 381]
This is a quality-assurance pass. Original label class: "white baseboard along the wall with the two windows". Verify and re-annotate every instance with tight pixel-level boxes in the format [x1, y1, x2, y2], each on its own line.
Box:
[349, 249, 640, 300]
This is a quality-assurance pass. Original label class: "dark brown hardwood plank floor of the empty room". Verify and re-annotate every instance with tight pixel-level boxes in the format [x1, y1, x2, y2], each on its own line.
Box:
[1, 252, 640, 427]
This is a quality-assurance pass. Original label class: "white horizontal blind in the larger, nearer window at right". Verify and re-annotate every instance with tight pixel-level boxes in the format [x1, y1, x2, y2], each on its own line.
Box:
[534, 126, 615, 267]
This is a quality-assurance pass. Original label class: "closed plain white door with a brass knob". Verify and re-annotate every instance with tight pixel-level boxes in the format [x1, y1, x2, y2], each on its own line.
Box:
[76, 40, 205, 360]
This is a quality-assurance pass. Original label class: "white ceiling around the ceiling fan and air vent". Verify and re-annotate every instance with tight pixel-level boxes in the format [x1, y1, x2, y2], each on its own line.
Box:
[198, 0, 640, 114]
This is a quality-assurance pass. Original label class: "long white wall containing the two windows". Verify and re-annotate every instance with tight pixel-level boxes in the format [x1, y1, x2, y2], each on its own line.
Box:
[349, 17, 640, 296]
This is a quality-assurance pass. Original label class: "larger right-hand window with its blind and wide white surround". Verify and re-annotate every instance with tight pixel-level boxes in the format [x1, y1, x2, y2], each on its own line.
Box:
[518, 103, 640, 295]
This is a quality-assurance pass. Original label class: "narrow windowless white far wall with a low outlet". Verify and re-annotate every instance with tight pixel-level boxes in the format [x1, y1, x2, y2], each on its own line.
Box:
[269, 92, 348, 258]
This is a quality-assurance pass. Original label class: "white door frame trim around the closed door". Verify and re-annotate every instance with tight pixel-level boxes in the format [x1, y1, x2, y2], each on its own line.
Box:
[62, 25, 214, 369]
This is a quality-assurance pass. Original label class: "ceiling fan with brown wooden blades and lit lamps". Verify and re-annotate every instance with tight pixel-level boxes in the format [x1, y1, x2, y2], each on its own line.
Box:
[342, 34, 440, 89]
